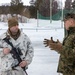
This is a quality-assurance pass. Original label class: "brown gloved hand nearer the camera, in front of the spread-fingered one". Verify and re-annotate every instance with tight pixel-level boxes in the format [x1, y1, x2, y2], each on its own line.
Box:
[49, 40, 62, 52]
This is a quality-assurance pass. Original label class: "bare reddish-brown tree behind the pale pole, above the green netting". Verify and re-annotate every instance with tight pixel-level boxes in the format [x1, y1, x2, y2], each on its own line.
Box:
[39, 0, 58, 17]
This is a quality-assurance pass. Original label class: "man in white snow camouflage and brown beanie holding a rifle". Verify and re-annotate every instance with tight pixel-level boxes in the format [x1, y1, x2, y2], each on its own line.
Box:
[0, 17, 34, 75]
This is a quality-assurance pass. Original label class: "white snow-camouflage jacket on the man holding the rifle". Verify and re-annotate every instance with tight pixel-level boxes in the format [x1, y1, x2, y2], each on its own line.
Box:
[0, 31, 34, 72]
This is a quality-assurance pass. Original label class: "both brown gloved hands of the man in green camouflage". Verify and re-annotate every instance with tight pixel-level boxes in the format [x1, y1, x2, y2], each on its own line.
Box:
[43, 37, 62, 52]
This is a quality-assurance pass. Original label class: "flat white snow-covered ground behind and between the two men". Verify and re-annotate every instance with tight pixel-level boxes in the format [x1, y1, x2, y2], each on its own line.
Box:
[0, 19, 64, 75]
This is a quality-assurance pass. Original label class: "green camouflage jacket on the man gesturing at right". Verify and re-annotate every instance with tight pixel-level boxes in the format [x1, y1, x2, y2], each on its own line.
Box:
[57, 27, 75, 73]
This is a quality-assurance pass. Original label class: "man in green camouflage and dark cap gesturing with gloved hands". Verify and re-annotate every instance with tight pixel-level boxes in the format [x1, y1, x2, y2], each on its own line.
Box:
[44, 13, 75, 75]
